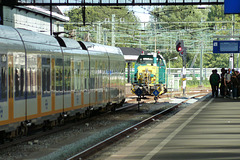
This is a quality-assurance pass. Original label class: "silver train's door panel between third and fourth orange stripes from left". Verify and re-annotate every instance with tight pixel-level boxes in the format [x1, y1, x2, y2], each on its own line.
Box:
[41, 57, 52, 113]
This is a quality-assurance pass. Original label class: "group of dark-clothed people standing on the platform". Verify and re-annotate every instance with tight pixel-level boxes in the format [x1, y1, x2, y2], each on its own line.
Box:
[209, 68, 240, 99]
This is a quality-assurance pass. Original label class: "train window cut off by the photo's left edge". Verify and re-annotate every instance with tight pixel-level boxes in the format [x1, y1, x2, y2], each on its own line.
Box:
[0, 67, 7, 100]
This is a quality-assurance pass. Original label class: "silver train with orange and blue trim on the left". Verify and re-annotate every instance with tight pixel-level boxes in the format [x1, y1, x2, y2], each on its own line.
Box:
[0, 26, 125, 141]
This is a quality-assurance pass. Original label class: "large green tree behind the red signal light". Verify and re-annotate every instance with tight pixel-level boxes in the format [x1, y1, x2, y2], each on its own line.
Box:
[149, 6, 208, 67]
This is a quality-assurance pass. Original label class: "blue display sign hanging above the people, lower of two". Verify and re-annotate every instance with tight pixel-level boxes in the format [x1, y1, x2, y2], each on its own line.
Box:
[213, 41, 240, 53]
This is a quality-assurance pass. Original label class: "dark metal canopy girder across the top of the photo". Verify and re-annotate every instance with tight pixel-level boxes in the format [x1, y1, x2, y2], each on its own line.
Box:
[0, 0, 224, 6]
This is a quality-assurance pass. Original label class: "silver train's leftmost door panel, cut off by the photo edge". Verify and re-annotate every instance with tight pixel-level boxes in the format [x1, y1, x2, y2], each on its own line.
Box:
[0, 54, 9, 124]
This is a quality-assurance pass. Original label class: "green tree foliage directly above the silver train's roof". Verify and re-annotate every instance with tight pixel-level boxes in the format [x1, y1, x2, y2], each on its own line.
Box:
[65, 6, 140, 45]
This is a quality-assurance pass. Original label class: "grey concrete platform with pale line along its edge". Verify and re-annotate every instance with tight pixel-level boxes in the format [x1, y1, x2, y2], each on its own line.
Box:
[108, 97, 240, 160]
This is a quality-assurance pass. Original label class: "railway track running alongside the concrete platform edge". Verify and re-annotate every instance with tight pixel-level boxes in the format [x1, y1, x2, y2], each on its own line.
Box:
[68, 92, 208, 160]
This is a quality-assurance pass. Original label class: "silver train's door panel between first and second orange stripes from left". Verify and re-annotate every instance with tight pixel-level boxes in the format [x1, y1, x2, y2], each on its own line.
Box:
[13, 52, 26, 120]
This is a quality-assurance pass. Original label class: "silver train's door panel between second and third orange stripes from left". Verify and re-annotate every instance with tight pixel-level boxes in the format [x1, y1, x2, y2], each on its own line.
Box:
[27, 56, 38, 116]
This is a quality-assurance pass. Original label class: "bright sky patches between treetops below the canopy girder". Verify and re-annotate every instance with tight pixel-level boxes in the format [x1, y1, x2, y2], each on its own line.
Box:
[59, 6, 151, 22]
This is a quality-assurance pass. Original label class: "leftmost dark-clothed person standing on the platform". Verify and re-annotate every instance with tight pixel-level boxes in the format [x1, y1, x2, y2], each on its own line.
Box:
[209, 70, 220, 98]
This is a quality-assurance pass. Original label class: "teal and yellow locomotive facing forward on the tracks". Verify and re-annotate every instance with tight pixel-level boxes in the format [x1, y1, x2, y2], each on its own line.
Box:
[132, 53, 167, 97]
